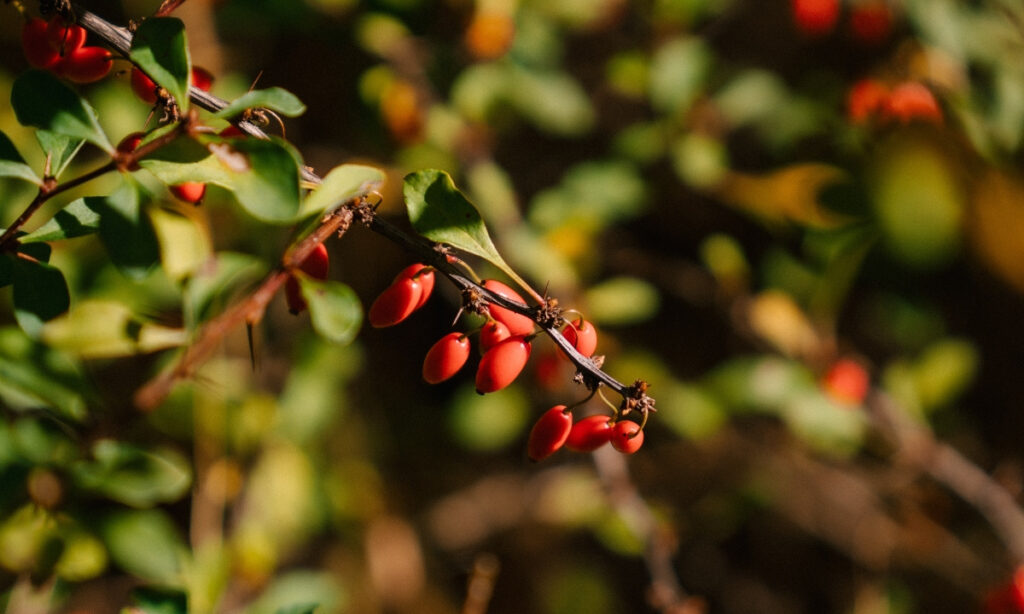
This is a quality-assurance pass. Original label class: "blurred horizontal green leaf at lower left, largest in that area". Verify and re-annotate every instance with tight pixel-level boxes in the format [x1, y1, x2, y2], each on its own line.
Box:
[72, 439, 191, 508]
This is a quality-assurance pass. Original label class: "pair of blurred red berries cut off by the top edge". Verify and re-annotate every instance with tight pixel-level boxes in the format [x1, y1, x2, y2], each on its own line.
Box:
[791, 0, 893, 45]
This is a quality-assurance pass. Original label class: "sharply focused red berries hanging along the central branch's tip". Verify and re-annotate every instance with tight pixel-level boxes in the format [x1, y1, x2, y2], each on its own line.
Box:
[369, 263, 643, 461]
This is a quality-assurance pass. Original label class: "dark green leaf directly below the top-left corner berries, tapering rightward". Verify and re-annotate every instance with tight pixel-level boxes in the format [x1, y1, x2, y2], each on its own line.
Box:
[10, 70, 114, 154]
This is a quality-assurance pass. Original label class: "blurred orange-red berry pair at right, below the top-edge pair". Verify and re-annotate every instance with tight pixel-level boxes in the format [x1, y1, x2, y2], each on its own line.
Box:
[846, 79, 942, 124]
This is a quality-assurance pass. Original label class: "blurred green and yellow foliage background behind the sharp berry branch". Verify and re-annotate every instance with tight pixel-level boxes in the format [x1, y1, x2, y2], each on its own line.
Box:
[0, 0, 1024, 614]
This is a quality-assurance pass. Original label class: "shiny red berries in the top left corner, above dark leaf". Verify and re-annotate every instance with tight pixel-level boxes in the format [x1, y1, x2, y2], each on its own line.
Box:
[22, 15, 114, 83]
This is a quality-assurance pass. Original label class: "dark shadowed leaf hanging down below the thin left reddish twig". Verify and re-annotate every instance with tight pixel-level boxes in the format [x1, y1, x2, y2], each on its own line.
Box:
[85, 180, 160, 280]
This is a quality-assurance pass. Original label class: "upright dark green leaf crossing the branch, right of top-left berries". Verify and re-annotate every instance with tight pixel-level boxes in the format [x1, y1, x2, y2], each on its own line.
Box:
[129, 17, 191, 113]
